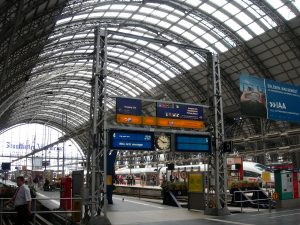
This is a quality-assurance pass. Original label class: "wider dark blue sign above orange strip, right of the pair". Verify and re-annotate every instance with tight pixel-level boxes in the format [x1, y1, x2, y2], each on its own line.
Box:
[156, 102, 203, 120]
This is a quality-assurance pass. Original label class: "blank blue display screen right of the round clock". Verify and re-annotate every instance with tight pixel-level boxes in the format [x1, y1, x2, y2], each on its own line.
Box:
[175, 134, 211, 153]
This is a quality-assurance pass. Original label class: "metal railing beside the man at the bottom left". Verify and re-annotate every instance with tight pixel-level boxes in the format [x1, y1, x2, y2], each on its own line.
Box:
[0, 197, 83, 225]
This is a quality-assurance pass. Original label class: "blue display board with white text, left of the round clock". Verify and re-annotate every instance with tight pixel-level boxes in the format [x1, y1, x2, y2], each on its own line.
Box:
[110, 130, 154, 151]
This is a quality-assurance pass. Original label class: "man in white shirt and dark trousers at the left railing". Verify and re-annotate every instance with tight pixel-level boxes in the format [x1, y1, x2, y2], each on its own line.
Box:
[7, 176, 31, 225]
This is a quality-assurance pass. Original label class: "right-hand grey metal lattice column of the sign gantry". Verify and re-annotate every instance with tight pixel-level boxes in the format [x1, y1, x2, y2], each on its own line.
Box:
[205, 53, 229, 215]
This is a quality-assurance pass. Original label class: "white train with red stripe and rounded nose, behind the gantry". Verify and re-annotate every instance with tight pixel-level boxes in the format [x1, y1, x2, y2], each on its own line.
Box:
[115, 161, 274, 186]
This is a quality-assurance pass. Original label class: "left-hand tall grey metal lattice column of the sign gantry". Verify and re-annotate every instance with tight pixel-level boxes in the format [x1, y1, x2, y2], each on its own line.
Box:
[85, 27, 107, 220]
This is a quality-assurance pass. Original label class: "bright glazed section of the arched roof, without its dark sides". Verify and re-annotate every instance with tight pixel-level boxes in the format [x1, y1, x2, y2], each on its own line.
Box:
[3, 0, 300, 153]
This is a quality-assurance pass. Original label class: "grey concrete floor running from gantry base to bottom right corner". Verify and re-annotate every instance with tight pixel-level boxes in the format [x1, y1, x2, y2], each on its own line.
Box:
[108, 196, 300, 225]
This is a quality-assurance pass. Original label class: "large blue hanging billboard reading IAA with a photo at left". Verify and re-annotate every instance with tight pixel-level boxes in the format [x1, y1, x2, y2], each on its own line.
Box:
[240, 74, 300, 122]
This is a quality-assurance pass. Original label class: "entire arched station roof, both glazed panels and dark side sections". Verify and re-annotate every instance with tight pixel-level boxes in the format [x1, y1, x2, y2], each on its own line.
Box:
[0, 0, 300, 154]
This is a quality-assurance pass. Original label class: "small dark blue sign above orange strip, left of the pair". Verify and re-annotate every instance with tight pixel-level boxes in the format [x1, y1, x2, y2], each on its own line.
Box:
[116, 98, 142, 116]
